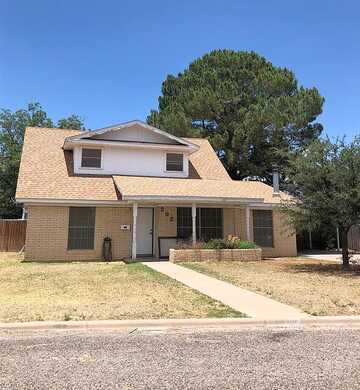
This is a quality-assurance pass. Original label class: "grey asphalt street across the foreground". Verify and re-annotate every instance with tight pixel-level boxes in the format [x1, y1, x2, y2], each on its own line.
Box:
[0, 329, 360, 390]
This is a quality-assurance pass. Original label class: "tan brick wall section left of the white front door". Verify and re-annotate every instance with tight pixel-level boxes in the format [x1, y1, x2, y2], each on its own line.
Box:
[25, 206, 132, 261]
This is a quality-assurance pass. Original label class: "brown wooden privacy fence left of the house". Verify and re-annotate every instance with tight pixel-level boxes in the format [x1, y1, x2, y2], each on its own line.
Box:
[0, 219, 26, 252]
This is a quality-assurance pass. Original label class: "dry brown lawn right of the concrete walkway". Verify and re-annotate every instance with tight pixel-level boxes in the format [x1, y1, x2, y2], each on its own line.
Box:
[182, 258, 360, 316]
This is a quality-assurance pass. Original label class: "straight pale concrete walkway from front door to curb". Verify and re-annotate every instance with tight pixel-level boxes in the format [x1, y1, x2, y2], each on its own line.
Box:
[143, 261, 309, 320]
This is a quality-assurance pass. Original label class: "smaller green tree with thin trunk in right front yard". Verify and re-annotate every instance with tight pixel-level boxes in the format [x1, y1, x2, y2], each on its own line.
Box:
[282, 138, 360, 268]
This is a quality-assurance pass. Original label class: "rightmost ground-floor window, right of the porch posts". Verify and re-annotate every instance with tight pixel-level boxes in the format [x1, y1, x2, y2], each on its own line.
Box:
[253, 210, 274, 247]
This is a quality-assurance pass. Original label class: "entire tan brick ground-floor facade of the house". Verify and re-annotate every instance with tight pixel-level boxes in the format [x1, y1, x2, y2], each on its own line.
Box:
[25, 206, 297, 261]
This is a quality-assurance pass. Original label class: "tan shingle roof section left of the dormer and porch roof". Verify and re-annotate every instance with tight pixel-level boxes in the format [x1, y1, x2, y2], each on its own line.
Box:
[16, 127, 119, 200]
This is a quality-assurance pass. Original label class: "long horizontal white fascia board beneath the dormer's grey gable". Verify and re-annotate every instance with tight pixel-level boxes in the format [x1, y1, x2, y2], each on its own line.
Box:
[63, 139, 198, 154]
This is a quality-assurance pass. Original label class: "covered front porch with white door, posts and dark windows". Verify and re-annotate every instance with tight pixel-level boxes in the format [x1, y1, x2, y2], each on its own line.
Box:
[131, 202, 274, 260]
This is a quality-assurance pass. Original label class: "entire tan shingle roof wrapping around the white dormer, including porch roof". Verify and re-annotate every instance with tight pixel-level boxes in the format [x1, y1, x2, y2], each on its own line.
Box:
[16, 127, 288, 203]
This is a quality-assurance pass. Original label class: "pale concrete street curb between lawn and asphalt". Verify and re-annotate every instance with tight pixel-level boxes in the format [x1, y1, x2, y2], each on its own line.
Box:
[0, 316, 360, 331]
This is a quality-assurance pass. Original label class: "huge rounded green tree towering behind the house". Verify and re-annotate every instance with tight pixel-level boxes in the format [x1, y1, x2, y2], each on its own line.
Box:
[147, 50, 324, 182]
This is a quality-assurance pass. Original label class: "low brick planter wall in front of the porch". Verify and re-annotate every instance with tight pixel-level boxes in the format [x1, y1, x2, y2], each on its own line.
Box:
[169, 248, 261, 263]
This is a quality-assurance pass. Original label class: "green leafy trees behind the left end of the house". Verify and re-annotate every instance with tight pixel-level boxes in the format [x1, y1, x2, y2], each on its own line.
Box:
[0, 103, 83, 218]
